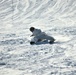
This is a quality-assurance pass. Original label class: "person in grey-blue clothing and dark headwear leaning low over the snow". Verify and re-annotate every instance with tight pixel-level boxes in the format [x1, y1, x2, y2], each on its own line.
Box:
[30, 27, 55, 45]
